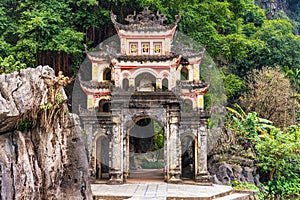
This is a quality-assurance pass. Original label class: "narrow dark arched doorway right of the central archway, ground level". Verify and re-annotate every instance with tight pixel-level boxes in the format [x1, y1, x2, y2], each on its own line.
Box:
[181, 135, 195, 179]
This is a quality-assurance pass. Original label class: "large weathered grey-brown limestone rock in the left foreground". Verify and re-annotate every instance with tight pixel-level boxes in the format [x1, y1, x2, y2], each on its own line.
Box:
[0, 66, 92, 199]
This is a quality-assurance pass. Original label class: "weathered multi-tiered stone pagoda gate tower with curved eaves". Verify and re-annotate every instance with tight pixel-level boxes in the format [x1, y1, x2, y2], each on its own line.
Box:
[79, 7, 209, 184]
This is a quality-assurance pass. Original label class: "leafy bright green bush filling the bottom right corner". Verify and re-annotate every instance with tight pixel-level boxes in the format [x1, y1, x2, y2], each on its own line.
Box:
[255, 125, 300, 199]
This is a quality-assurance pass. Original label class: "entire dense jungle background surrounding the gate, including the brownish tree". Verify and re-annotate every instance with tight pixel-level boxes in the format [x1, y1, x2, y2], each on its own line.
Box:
[0, 0, 300, 199]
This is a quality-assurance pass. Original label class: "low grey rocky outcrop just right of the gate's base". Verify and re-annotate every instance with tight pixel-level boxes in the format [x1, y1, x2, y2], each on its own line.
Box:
[208, 128, 260, 187]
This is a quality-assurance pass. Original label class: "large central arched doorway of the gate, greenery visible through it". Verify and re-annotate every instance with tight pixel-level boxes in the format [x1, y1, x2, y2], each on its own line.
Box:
[128, 117, 165, 179]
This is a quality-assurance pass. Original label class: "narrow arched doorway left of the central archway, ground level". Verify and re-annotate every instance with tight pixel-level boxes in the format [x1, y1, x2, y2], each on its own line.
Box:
[95, 136, 109, 179]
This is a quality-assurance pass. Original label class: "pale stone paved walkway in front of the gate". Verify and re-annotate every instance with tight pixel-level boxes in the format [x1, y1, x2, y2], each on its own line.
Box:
[92, 183, 232, 200]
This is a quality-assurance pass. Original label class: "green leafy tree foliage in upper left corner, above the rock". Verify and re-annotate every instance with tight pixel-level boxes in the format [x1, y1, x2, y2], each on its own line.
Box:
[0, 0, 85, 70]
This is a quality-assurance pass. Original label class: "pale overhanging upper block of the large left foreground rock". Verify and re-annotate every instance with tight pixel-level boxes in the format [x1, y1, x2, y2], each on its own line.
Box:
[0, 66, 54, 134]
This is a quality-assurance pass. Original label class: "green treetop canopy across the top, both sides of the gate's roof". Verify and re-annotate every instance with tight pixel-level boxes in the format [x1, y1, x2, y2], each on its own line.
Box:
[0, 0, 300, 76]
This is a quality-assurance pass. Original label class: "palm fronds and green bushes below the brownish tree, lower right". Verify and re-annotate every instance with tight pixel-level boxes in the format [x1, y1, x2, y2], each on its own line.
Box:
[228, 105, 300, 199]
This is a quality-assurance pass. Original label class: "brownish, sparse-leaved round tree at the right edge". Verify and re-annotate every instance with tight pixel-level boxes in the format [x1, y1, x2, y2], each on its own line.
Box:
[241, 67, 293, 127]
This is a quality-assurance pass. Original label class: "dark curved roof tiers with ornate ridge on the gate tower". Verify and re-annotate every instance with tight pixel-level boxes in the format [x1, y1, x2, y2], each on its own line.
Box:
[80, 7, 207, 93]
